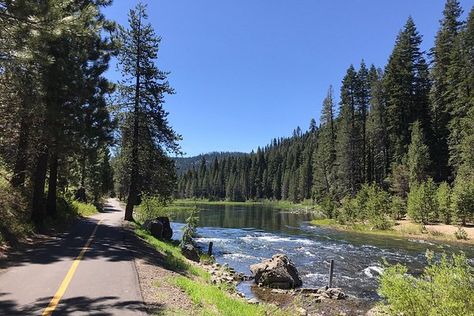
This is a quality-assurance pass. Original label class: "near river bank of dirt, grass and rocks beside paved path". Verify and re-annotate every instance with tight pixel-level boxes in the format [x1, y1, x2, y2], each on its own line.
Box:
[132, 226, 373, 316]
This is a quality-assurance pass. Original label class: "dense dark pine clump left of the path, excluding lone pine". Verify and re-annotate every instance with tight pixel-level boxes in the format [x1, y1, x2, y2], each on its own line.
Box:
[0, 0, 115, 226]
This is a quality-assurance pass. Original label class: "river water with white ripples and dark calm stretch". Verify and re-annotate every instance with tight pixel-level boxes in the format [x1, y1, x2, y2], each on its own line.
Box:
[168, 205, 474, 300]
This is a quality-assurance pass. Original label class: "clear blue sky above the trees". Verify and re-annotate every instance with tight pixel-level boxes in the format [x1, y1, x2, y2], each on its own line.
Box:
[105, 0, 474, 156]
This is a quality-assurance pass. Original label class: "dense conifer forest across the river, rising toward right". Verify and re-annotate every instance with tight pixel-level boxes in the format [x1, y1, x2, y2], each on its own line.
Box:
[176, 0, 474, 225]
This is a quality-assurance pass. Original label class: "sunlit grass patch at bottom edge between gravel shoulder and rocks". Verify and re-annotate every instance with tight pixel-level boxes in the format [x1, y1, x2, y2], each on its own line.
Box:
[170, 276, 285, 316]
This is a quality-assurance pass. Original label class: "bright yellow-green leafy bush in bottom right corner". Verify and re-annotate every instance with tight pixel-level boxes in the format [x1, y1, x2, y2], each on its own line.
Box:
[379, 253, 474, 316]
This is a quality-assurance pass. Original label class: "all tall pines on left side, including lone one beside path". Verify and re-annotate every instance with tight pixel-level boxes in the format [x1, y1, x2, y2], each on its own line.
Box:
[0, 0, 179, 226]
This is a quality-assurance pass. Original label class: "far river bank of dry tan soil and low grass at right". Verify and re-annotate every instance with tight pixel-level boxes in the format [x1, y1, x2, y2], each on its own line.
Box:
[310, 219, 474, 245]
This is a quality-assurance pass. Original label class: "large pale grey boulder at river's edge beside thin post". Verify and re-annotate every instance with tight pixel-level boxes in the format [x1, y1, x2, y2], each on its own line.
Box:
[250, 254, 303, 289]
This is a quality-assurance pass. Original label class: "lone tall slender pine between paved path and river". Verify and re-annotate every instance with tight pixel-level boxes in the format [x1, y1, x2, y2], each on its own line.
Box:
[119, 4, 180, 220]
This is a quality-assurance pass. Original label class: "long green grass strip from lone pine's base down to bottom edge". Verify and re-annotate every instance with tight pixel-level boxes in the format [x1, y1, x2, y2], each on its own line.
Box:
[135, 224, 286, 316]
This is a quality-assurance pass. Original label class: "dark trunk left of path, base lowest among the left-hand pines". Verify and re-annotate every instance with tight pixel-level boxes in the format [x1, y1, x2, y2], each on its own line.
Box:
[31, 146, 48, 226]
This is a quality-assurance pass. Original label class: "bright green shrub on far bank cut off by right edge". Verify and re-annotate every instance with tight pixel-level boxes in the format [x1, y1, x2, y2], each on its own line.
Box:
[452, 177, 474, 225]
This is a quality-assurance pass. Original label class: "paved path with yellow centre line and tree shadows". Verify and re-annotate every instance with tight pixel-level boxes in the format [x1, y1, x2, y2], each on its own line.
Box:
[0, 199, 146, 315]
